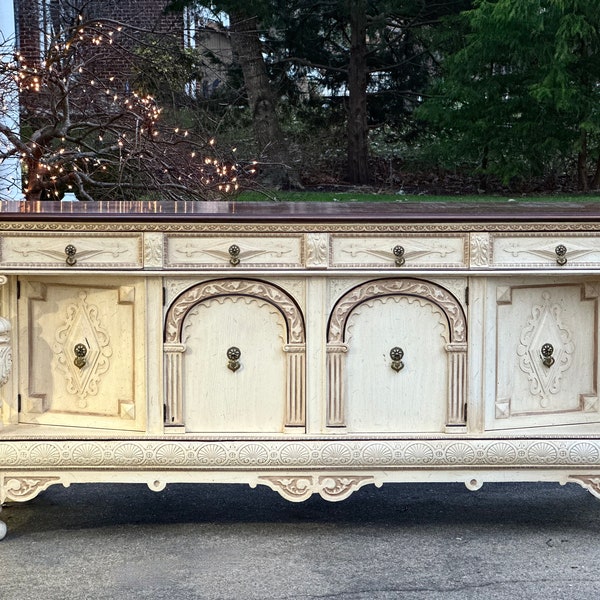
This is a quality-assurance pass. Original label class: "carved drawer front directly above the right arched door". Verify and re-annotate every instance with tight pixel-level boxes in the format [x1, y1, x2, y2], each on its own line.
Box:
[330, 233, 468, 269]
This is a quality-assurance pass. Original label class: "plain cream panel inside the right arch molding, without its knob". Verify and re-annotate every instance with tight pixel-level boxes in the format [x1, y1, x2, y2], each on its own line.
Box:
[345, 296, 448, 432]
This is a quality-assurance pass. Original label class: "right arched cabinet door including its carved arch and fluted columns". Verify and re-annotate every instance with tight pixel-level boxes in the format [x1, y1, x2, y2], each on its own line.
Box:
[327, 278, 467, 433]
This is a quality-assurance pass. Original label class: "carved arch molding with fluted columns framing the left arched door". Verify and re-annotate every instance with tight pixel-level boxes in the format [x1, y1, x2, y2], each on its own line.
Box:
[163, 279, 306, 427]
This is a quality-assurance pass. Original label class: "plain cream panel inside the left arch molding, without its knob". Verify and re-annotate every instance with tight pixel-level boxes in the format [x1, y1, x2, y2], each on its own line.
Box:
[182, 296, 287, 432]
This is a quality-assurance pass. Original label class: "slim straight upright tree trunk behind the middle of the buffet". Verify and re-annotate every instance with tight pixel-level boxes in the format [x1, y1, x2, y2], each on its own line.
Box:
[348, 0, 369, 185]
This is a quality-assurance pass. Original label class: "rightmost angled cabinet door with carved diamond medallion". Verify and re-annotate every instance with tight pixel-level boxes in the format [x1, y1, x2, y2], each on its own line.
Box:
[487, 279, 600, 429]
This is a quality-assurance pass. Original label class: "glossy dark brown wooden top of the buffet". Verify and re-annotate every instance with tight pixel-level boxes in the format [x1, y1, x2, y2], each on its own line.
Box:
[0, 199, 600, 223]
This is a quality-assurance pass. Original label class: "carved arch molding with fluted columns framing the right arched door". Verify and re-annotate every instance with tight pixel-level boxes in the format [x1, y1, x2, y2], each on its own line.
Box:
[327, 278, 467, 428]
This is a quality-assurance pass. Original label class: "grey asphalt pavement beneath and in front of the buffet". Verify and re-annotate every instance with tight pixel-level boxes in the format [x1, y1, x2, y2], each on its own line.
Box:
[0, 483, 600, 600]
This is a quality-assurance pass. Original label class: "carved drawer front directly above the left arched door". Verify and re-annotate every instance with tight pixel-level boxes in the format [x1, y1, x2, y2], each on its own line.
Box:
[165, 234, 304, 270]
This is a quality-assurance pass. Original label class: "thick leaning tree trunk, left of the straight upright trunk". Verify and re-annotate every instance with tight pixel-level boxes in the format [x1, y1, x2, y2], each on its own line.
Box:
[229, 12, 299, 189]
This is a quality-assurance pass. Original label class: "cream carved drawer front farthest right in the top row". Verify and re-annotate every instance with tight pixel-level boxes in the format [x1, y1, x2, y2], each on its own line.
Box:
[490, 232, 600, 268]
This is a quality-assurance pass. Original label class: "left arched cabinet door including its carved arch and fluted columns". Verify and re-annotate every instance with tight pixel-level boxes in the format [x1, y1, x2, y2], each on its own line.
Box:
[165, 279, 304, 433]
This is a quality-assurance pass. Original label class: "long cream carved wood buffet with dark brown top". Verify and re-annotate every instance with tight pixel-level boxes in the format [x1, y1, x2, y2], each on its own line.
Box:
[0, 202, 600, 537]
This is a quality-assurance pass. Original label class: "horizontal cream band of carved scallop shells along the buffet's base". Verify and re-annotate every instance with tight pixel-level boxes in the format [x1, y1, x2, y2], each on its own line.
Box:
[0, 436, 600, 477]
